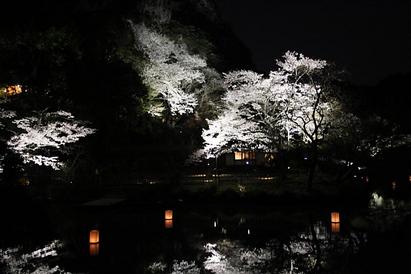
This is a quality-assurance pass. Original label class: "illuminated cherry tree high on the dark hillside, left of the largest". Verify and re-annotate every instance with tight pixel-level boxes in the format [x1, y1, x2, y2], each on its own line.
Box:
[129, 21, 207, 116]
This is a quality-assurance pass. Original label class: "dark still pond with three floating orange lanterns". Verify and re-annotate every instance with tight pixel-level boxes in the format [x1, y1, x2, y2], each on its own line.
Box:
[0, 193, 411, 273]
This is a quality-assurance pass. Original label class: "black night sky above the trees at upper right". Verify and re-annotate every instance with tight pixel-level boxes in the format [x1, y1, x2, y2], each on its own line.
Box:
[216, 0, 411, 85]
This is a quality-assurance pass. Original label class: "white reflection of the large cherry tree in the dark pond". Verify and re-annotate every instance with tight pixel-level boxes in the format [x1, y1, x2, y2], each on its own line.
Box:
[204, 222, 365, 273]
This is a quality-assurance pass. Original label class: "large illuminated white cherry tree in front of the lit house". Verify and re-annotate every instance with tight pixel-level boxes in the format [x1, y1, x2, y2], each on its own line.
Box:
[202, 51, 354, 188]
